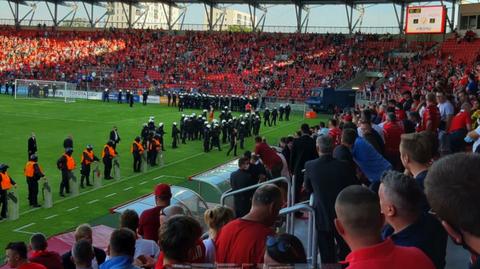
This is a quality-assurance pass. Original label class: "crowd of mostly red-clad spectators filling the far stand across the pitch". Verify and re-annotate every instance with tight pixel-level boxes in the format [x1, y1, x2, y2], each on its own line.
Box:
[0, 27, 414, 99]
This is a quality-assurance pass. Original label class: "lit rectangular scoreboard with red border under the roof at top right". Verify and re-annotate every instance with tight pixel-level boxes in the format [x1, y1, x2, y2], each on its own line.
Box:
[405, 6, 447, 34]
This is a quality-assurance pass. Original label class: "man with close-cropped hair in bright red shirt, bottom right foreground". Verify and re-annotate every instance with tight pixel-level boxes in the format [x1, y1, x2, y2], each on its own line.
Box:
[335, 185, 435, 269]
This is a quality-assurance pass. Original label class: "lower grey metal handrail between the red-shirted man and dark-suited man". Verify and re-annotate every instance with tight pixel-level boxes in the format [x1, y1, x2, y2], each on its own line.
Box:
[279, 201, 318, 268]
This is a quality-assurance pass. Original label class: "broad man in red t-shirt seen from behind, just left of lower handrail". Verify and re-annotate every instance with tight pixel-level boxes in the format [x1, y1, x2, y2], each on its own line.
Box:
[215, 184, 282, 265]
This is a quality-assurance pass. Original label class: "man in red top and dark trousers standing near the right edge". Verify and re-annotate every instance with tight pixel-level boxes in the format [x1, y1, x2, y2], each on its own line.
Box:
[448, 103, 472, 153]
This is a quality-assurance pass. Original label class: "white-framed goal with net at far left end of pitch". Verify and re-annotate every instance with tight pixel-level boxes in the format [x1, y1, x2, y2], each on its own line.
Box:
[15, 79, 77, 103]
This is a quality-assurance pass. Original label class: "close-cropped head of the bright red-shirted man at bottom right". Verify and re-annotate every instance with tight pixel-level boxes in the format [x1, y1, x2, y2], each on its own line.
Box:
[335, 185, 383, 236]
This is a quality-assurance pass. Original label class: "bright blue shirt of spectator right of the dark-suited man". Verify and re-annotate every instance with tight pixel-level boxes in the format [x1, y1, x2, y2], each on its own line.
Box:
[352, 137, 392, 183]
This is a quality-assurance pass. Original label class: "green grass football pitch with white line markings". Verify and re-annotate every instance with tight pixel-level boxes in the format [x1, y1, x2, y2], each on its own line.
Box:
[0, 95, 326, 249]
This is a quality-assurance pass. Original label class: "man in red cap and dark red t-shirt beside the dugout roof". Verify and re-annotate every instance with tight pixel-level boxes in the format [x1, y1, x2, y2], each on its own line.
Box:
[138, 183, 172, 242]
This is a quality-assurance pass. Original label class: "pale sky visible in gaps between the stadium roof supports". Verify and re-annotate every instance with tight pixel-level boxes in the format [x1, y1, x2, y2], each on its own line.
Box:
[0, 1, 458, 32]
